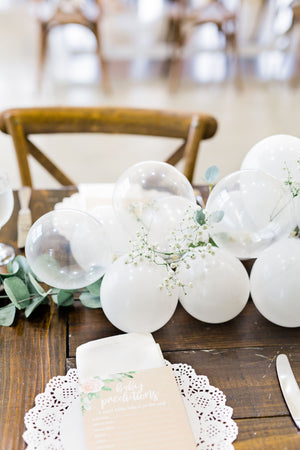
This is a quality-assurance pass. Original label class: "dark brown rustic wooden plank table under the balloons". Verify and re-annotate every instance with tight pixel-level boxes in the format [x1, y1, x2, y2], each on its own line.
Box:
[0, 189, 300, 450]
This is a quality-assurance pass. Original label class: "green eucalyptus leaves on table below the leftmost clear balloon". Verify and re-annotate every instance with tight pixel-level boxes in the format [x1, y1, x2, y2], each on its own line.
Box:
[0, 255, 102, 326]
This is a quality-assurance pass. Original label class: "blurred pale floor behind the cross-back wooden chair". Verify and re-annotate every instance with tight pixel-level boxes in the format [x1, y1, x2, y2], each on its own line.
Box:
[0, 0, 300, 187]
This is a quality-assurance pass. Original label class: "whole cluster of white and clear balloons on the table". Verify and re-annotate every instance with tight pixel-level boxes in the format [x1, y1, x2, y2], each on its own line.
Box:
[25, 136, 300, 332]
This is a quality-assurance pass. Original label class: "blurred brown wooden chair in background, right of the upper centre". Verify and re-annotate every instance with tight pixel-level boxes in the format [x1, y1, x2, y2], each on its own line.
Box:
[169, 0, 241, 92]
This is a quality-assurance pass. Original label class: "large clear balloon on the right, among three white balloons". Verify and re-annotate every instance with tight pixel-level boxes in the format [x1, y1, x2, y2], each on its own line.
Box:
[206, 170, 293, 259]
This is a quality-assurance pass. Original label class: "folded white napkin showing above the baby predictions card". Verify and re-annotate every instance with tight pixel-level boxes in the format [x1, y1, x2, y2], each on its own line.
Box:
[76, 333, 165, 381]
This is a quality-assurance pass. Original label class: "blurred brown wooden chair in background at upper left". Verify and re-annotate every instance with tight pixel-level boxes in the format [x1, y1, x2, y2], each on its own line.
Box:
[36, 0, 111, 93]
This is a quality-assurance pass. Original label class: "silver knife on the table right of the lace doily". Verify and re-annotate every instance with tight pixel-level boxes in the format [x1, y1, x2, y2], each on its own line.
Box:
[276, 354, 300, 429]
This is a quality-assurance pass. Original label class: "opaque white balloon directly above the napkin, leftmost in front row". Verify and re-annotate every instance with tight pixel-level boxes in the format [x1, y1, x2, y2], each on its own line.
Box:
[100, 256, 178, 333]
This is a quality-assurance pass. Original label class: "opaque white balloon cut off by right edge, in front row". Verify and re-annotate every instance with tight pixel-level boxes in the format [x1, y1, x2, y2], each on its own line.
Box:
[250, 238, 300, 327]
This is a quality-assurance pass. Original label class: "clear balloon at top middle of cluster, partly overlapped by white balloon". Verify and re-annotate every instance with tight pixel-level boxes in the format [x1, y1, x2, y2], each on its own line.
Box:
[113, 161, 195, 237]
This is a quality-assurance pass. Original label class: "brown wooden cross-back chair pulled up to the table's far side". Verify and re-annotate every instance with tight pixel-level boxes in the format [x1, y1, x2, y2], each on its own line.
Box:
[0, 107, 217, 186]
